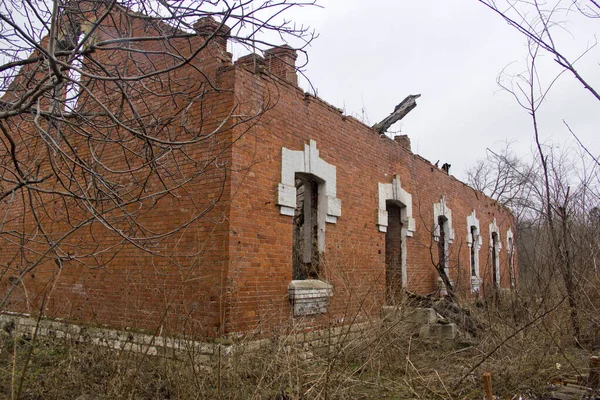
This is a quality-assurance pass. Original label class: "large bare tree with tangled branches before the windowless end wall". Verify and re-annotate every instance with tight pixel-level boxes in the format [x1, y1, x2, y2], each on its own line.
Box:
[0, 0, 314, 324]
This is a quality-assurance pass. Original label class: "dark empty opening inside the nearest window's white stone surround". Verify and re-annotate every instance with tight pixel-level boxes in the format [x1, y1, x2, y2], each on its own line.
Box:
[292, 174, 320, 280]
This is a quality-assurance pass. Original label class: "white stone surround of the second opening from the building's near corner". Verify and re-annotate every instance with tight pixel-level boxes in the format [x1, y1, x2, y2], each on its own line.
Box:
[377, 175, 416, 287]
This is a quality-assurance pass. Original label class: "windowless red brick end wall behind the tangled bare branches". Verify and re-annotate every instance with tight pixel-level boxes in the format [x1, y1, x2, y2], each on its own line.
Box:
[0, 9, 235, 336]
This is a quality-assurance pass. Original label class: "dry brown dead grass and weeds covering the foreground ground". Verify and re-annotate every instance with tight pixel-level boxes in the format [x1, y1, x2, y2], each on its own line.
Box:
[0, 284, 594, 400]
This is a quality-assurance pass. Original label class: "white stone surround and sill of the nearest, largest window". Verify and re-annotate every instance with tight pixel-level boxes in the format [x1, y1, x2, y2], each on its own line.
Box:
[277, 139, 342, 316]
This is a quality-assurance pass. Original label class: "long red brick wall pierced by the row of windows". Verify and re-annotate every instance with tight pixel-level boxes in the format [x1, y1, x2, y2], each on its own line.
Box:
[227, 68, 515, 331]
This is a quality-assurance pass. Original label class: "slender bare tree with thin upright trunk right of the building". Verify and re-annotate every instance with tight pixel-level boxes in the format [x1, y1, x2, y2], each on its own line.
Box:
[468, 33, 598, 342]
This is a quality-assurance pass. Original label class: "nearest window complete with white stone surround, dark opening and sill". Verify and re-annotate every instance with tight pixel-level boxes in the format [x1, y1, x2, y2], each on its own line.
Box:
[276, 140, 342, 316]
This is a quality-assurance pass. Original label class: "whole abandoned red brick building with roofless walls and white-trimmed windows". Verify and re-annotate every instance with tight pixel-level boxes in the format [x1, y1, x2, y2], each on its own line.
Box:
[0, 4, 517, 336]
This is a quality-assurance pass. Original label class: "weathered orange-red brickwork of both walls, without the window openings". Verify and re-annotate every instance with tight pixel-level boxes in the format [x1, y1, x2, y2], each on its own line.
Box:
[0, 10, 516, 336]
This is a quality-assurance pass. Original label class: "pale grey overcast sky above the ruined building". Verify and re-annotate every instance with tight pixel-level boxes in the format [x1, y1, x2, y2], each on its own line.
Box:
[255, 0, 600, 180]
